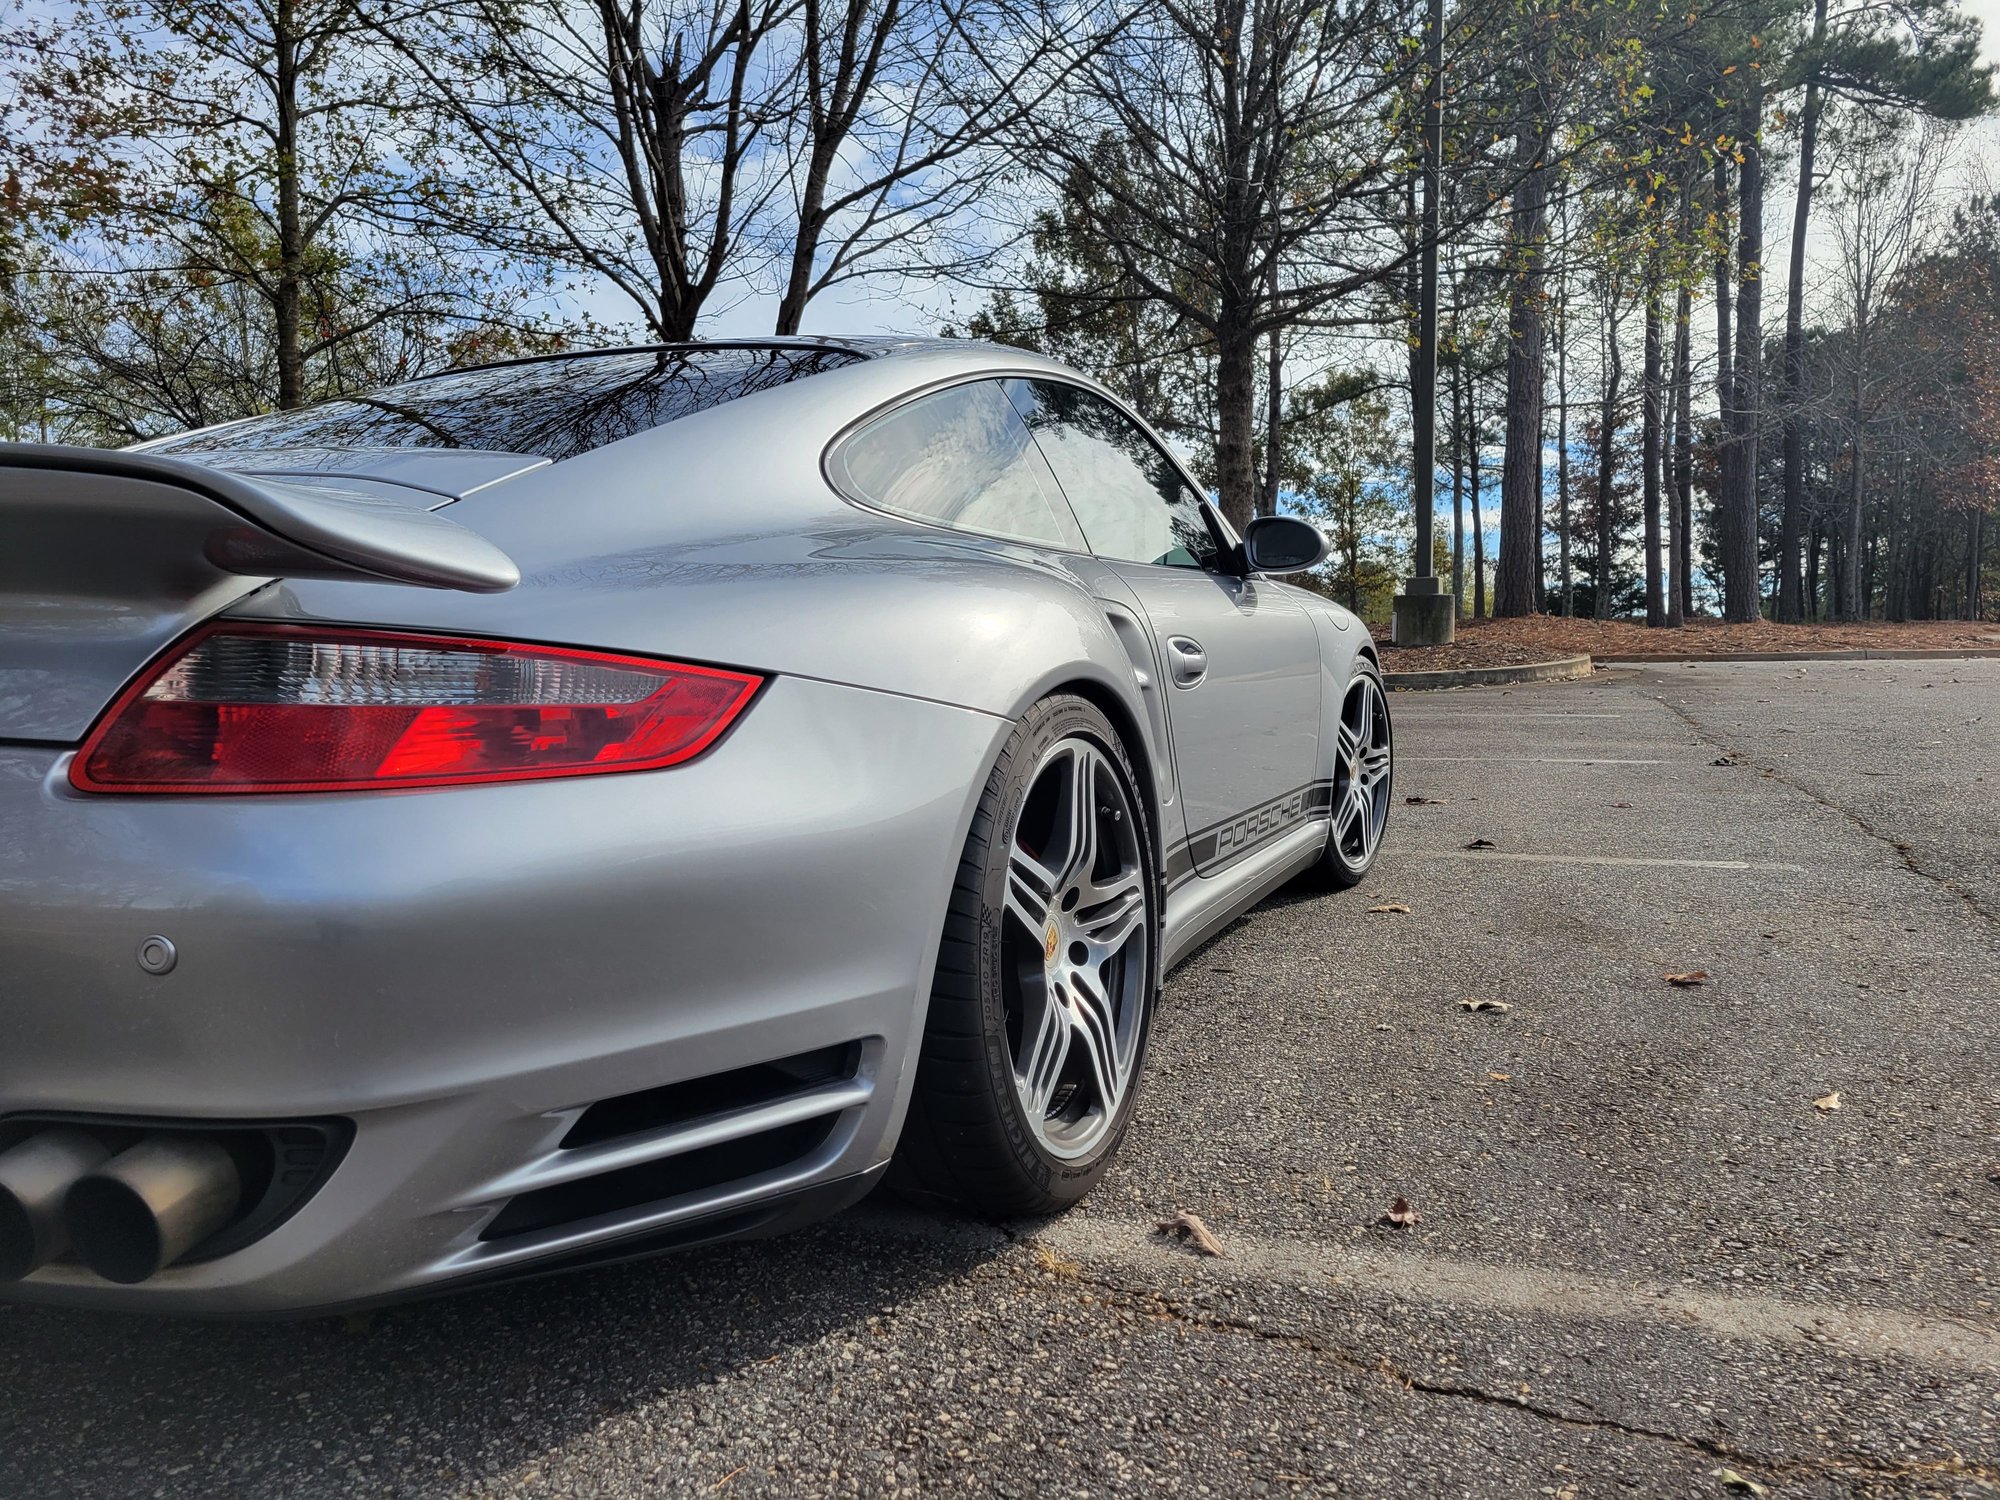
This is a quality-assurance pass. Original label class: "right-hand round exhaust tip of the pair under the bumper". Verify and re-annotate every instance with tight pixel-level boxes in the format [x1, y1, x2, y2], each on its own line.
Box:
[64, 1136, 242, 1286]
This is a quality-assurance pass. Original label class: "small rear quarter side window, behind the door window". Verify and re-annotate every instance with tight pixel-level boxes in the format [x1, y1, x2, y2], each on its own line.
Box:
[834, 380, 1082, 552]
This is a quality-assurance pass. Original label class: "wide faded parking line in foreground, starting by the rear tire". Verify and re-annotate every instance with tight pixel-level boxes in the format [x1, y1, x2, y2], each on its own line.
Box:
[1030, 1212, 2000, 1372]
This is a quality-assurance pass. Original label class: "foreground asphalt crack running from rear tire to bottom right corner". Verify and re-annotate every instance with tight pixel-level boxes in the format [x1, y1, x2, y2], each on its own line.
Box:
[1048, 1264, 2000, 1490]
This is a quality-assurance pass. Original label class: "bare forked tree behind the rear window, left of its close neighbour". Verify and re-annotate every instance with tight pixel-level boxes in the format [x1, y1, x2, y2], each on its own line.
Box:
[376, 0, 804, 342]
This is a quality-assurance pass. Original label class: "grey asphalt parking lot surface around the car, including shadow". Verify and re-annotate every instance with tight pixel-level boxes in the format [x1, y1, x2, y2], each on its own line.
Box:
[0, 660, 2000, 1498]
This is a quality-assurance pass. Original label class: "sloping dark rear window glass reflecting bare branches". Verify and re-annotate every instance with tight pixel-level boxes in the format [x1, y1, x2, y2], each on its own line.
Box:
[148, 344, 862, 462]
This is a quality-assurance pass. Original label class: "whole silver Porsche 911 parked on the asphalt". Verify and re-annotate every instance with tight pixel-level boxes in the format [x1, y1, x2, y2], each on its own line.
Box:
[0, 340, 1390, 1312]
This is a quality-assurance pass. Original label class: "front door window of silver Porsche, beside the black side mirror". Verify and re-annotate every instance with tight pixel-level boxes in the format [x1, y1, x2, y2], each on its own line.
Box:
[1006, 380, 1218, 568]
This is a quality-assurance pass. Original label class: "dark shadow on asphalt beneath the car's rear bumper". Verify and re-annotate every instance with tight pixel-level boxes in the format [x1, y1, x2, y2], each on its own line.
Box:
[0, 1196, 1008, 1496]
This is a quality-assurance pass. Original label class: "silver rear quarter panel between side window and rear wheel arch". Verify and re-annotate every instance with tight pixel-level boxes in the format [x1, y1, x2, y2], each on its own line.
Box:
[232, 352, 1174, 856]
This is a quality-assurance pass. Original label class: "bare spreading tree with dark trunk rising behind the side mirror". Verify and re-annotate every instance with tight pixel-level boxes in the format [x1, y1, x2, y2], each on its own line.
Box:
[984, 0, 1472, 526]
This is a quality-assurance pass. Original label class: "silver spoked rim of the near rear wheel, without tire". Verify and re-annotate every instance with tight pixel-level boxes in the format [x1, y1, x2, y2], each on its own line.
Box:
[1000, 734, 1158, 1160]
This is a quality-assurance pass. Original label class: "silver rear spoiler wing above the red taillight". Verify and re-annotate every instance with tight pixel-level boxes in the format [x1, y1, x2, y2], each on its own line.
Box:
[0, 442, 520, 594]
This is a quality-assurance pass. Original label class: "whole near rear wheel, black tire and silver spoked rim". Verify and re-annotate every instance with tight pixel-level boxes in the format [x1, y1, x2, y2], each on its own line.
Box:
[896, 696, 1160, 1218]
